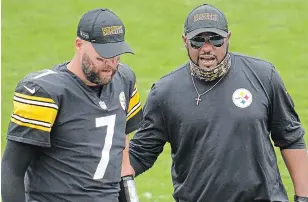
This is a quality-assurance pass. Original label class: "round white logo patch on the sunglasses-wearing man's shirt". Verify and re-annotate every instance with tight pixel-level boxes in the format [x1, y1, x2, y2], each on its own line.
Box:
[232, 88, 252, 108]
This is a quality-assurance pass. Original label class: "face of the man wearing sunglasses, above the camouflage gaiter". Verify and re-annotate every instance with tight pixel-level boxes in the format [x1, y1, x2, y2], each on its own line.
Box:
[183, 33, 231, 68]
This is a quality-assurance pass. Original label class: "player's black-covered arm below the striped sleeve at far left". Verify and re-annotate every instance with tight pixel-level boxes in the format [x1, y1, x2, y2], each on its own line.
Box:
[1, 140, 38, 202]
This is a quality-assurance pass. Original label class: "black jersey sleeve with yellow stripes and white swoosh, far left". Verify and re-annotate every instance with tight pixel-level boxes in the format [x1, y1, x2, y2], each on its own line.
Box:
[7, 81, 58, 147]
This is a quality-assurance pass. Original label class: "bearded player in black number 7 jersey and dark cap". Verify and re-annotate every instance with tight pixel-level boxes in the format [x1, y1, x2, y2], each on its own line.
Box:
[1, 8, 142, 202]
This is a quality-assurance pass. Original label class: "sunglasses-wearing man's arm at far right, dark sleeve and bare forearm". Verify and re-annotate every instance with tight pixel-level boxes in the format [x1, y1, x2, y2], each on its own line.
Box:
[269, 69, 308, 199]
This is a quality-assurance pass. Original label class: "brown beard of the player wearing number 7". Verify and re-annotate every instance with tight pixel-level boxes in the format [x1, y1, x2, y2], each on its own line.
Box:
[81, 54, 116, 85]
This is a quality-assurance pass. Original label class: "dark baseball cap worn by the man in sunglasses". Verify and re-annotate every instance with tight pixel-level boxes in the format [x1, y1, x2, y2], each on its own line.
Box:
[184, 4, 228, 39]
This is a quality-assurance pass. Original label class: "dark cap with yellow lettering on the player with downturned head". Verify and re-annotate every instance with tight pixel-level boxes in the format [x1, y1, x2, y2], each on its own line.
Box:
[77, 8, 134, 58]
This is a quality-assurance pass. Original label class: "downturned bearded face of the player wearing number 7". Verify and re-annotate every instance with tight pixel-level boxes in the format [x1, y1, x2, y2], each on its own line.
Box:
[81, 43, 120, 85]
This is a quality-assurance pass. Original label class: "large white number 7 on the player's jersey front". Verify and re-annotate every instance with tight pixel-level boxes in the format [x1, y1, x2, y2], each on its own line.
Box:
[93, 114, 116, 180]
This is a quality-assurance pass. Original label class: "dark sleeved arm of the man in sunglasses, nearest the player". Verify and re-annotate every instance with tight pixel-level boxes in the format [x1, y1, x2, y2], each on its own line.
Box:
[129, 85, 168, 176]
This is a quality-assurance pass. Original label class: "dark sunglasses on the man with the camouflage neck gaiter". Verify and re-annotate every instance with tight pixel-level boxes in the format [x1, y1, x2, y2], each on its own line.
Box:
[189, 35, 225, 49]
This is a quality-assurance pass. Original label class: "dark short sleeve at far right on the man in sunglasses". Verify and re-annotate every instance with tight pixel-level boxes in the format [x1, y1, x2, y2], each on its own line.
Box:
[270, 69, 305, 148]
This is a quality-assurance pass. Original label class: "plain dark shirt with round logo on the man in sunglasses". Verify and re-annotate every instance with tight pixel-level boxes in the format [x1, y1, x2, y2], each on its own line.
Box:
[130, 54, 304, 202]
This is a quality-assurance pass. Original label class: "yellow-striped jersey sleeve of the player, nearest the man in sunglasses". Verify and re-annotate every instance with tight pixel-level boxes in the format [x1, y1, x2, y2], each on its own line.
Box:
[126, 74, 143, 134]
